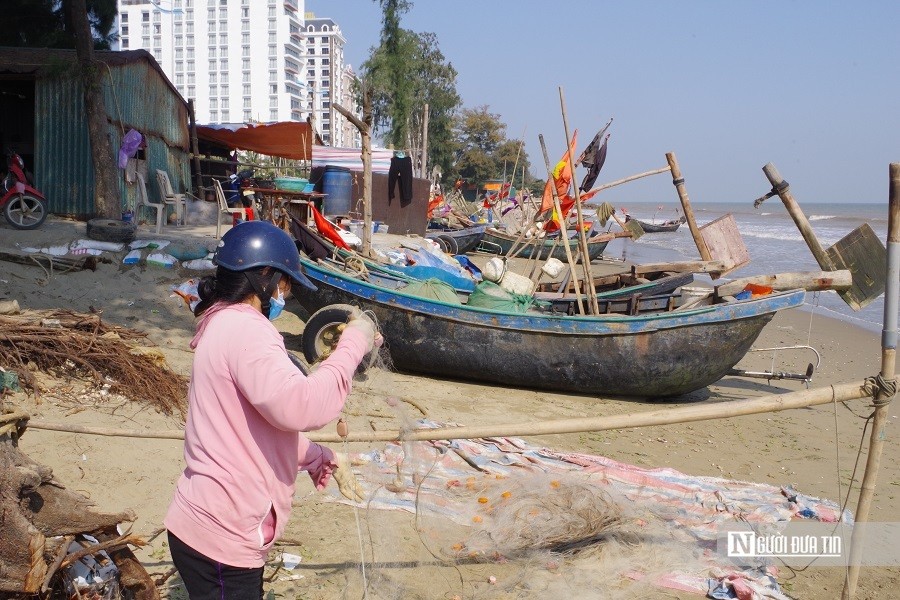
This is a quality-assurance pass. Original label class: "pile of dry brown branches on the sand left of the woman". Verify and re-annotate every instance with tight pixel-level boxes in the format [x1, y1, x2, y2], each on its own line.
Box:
[0, 310, 188, 417]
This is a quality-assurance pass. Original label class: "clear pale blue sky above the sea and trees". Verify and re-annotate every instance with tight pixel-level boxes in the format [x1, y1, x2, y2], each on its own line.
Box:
[306, 0, 900, 205]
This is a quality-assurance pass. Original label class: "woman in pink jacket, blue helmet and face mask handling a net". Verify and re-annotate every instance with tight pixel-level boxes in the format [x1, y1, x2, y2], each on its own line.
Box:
[165, 221, 376, 600]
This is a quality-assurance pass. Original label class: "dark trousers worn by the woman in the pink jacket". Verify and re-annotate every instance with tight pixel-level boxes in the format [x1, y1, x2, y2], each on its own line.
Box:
[169, 533, 263, 600]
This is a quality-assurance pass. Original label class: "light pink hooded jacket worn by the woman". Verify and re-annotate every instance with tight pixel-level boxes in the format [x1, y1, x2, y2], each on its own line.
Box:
[164, 304, 368, 568]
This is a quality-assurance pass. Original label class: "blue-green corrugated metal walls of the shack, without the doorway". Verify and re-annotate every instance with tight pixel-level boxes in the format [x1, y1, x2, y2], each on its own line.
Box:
[34, 60, 190, 218]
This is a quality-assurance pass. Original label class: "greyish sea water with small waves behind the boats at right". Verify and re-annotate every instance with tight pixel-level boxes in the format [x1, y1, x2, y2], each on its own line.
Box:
[604, 197, 888, 331]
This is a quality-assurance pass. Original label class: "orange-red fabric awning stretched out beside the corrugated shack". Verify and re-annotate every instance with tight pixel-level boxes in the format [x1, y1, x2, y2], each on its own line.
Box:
[197, 121, 313, 160]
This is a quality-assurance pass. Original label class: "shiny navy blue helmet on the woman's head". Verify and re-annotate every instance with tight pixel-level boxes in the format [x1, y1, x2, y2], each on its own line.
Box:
[213, 221, 316, 291]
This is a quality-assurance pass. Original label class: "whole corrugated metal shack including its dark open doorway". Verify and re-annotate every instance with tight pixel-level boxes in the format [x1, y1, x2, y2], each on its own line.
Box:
[0, 48, 190, 219]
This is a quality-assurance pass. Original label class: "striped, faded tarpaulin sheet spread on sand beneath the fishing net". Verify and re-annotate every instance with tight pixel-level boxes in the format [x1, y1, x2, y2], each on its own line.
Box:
[326, 420, 853, 600]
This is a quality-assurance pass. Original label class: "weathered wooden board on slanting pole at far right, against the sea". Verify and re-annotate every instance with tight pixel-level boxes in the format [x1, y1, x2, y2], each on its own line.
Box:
[825, 223, 887, 310]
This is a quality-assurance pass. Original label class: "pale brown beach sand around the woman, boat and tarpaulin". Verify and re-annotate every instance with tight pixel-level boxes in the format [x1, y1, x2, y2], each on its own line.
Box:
[0, 218, 900, 599]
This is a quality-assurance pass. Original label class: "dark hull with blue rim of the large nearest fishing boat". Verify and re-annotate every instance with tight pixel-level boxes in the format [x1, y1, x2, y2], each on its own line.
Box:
[297, 257, 805, 397]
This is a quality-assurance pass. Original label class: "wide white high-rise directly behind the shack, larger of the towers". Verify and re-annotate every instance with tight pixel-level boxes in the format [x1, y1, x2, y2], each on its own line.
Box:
[118, 0, 311, 123]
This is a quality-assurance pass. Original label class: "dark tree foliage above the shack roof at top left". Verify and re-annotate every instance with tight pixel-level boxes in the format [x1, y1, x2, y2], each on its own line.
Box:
[0, 0, 118, 50]
